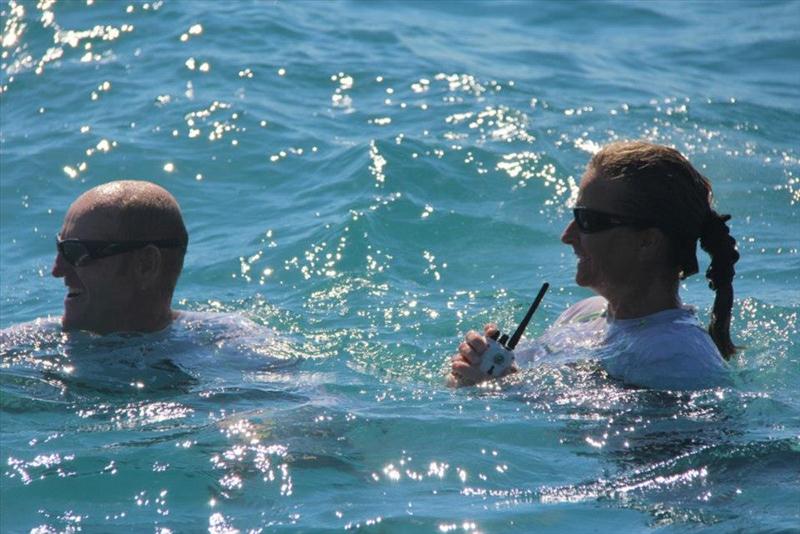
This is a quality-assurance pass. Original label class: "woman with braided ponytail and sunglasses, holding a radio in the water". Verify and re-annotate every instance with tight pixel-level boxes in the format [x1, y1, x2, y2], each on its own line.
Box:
[449, 141, 739, 389]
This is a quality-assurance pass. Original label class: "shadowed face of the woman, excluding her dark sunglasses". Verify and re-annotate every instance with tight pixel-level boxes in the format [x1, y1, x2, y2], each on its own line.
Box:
[561, 169, 646, 301]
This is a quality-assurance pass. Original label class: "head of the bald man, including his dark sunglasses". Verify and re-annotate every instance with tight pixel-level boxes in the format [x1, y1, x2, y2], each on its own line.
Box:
[53, 180, 189, 334]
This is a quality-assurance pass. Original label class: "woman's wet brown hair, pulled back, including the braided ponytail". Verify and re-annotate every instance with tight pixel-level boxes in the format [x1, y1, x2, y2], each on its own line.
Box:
[589, 141, 739, 359]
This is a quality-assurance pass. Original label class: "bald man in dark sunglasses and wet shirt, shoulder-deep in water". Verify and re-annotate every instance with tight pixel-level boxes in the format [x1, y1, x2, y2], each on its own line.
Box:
[0, 180, 299, 397]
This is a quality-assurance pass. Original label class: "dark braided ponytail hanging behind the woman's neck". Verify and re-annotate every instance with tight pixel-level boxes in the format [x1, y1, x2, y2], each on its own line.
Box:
[700, 209, 739, 360]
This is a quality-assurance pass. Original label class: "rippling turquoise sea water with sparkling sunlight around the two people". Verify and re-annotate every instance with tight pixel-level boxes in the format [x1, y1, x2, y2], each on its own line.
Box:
[0, 0, 800, 533]
